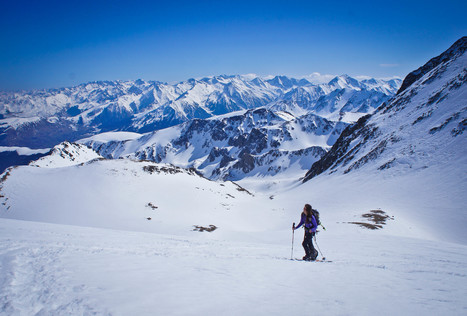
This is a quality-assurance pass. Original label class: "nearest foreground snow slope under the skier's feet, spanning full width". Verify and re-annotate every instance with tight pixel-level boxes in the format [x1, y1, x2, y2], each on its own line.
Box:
[0, 219, 467, 315]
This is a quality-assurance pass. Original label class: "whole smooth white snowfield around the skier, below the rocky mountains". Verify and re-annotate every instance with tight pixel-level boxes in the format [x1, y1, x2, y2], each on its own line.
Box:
[0, 153, 467, 315]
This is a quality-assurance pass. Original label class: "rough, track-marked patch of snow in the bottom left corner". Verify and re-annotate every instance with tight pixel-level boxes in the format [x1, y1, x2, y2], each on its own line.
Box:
[0, 231, 105, 315]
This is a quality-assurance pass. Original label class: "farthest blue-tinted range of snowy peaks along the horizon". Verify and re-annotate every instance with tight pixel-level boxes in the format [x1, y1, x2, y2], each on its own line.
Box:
[0, 75, 401, 148]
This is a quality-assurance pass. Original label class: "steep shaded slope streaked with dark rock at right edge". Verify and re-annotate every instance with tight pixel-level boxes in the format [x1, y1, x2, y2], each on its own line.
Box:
[305, 37, 467, 181]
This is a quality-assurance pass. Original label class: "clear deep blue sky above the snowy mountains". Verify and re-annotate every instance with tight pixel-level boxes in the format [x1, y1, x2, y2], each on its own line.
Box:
[0, 0, 467, 90]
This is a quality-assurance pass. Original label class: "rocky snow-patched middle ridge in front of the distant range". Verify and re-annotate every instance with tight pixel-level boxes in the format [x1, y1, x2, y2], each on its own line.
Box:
[80, 108, 348, 180]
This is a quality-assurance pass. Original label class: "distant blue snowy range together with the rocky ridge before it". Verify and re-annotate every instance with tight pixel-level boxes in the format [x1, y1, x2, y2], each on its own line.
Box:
[0, 75, 401, 180]
